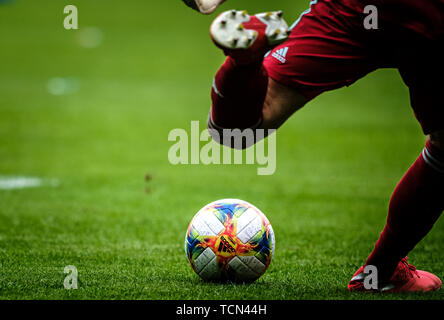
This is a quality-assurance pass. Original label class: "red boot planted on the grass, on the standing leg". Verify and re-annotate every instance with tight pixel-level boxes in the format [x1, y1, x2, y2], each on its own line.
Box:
[348, 258, 442, 293]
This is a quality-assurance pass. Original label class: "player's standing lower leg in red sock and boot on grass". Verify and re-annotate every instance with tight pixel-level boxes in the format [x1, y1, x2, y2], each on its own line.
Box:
[349, 131, 444, 292]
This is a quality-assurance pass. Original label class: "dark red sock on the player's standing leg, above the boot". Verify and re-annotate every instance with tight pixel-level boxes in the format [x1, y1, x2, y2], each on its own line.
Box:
[366, 141, 444, 281]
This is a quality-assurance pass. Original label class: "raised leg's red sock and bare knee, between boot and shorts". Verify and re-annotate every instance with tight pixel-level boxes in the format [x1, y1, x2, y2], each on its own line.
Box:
[209, 58, 308, 129]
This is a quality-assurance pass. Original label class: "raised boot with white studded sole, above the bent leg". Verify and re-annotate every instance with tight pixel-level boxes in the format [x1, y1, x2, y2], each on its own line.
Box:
[210, 10, 290, 64]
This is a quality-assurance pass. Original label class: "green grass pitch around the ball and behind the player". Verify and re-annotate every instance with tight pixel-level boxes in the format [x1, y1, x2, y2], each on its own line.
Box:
[0, 0, 444, 299]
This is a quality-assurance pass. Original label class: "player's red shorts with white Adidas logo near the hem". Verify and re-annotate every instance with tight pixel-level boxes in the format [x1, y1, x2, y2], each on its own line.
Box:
[264, 0, 444, 134]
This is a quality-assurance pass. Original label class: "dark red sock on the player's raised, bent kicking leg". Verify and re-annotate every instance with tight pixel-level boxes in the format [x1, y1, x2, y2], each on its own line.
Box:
[208, 57, 268, 130]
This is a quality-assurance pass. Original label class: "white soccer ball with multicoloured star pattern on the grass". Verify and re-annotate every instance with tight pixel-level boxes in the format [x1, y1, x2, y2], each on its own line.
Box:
[185, 199, 275, 282]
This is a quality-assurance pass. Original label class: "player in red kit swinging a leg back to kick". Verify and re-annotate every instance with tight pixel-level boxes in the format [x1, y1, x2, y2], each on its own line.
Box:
[183, 0, 444, 292]
